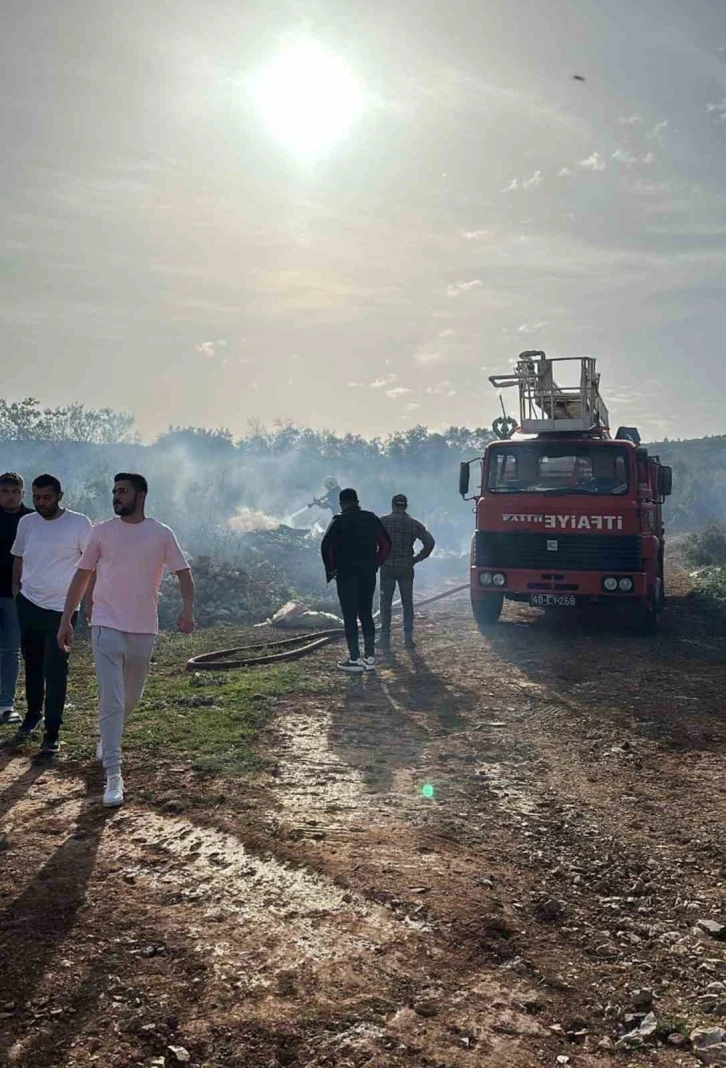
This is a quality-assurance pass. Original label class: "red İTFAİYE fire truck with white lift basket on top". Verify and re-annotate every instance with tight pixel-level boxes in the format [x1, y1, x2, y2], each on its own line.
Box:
[459, 351, 672, 631]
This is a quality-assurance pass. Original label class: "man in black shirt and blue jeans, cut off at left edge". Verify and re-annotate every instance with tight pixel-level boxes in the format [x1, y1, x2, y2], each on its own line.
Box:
[0, 471, 32, 723]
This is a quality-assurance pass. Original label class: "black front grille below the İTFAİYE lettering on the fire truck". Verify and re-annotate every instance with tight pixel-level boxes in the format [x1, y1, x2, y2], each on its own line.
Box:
[473, 531, 643, 571]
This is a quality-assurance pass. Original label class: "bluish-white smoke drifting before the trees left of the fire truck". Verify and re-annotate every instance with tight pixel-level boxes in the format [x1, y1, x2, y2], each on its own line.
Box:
[3, 426, 486, 566]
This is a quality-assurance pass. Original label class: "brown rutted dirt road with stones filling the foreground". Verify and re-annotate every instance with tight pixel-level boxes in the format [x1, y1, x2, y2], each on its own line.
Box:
[0, 576, 726, 1068]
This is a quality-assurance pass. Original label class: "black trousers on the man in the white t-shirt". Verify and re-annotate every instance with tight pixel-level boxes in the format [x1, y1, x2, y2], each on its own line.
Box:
[16, 594, 77, 739]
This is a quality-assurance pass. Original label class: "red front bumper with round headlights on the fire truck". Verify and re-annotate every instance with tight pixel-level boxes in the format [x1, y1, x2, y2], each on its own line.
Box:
[471, 566, 648, 607]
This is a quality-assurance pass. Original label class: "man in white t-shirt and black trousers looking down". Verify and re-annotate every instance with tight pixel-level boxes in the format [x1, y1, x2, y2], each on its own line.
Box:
[11, 474, 91, 756]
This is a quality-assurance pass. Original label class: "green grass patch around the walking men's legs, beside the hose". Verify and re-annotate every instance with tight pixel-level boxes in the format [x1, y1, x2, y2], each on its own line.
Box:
[18, 627, 306, 776]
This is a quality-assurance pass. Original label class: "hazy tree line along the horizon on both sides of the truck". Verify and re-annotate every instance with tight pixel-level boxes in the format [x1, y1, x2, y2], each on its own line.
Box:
[0, 397, 726, 530]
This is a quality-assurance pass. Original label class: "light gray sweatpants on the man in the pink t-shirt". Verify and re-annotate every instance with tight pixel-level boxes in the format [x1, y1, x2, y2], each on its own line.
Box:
[91, 627, 156, 774]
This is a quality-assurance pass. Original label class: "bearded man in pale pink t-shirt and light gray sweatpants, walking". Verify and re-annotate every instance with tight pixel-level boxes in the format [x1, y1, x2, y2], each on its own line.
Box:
[58, 472, 194, 806]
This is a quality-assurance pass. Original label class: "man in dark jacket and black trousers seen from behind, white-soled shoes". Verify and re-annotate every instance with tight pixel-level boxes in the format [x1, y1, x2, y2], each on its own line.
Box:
[320, 489, 391, 675]
